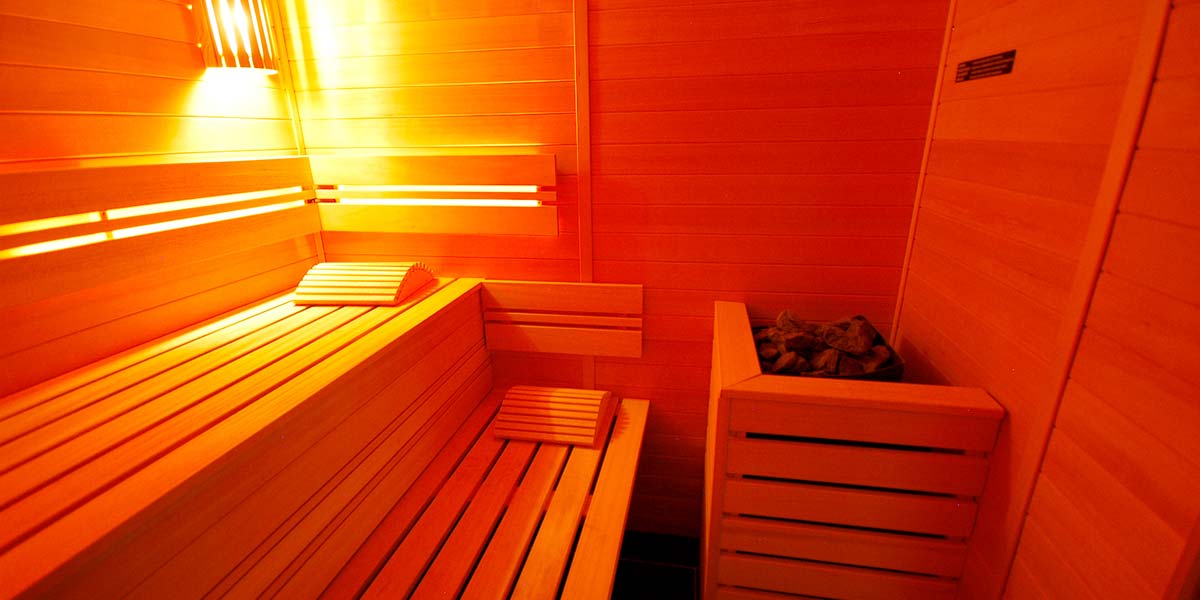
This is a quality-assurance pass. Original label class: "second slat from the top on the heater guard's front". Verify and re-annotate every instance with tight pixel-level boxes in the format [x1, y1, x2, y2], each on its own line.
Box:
[725, 438, 988, 496]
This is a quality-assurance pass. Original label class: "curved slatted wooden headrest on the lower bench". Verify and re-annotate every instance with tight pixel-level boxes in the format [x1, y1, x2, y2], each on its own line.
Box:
[492, 385, 614, 448]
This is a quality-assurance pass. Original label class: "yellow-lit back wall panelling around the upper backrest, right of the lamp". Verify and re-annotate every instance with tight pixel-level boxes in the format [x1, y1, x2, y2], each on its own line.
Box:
[282, 0, 580, 284]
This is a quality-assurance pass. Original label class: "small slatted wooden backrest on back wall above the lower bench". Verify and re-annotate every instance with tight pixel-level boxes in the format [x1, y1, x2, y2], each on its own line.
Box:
[482, 281, 642, 358]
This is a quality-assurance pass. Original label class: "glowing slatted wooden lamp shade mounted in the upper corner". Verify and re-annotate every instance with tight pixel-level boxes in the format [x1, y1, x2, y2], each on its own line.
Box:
[197, 0, 278, 71]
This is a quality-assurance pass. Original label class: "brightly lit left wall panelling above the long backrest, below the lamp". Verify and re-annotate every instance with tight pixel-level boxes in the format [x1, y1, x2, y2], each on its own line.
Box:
[0, 0, 299, 172]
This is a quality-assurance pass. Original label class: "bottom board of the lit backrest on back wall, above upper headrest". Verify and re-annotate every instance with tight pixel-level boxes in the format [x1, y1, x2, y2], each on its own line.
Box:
[318, 203, 558, 235]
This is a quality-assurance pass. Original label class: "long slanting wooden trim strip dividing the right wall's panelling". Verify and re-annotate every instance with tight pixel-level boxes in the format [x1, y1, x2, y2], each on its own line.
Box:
[1003, 0, 1171, 595]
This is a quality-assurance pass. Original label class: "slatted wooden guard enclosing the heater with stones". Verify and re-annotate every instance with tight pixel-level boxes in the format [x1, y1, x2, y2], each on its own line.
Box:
[703, 302, 1003, 600]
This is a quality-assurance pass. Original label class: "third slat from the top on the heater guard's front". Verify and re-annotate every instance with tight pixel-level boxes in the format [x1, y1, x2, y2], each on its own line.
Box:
[722, 479, 976, 538]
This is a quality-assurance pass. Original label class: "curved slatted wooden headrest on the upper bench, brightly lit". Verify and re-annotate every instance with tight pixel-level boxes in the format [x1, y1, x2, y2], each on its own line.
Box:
[294, 263, 433, 306]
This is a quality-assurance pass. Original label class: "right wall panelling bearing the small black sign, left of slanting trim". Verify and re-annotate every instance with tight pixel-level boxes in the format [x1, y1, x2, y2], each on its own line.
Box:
[895, 0, 1176, 599]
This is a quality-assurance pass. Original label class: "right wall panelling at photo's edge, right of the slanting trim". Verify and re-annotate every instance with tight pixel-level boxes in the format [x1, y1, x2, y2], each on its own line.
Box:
[1007, 2, 1200, 598]
